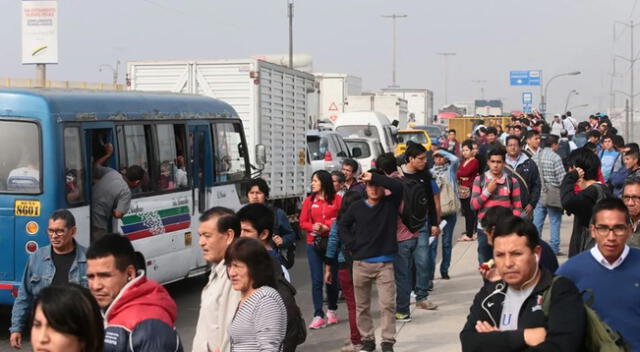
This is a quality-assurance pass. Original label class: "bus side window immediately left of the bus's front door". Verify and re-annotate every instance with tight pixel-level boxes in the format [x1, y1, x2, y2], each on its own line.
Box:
[156, 124, 189, 191]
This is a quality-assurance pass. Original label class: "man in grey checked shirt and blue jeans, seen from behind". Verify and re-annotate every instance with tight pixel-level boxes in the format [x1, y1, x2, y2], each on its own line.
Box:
[533, 135, 566, 255]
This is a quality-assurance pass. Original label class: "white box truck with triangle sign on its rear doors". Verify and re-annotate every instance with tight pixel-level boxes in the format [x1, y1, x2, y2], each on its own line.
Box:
[314, 73, 362, 122]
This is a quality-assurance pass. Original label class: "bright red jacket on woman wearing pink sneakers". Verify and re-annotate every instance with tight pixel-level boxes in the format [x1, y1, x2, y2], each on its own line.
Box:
[300, 194, 342, 244]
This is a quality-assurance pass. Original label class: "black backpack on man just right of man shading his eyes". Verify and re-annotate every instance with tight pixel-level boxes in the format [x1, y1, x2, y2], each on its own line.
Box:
[400, 177, 431, 232]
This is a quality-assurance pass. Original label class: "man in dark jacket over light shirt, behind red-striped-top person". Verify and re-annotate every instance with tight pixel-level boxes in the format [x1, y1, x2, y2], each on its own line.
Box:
[506, 136, 541, 219]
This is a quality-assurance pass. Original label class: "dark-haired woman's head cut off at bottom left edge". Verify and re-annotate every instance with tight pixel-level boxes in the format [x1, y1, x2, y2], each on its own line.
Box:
[31, 284, 104, 352]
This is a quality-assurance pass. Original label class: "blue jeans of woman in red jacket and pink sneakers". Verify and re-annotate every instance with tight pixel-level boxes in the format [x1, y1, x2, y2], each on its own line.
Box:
[307, 244, 338, 318]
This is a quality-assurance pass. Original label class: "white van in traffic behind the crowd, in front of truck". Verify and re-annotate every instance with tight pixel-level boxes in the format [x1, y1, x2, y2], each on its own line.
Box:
[333, 111, 397, 153]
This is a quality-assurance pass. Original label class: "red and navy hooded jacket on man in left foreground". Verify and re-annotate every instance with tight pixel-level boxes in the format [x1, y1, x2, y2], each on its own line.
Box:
[104, 274, 183, 352]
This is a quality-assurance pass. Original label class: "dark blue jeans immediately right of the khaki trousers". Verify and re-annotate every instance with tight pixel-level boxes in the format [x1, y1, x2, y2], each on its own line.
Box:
[393, 238, 418, 314]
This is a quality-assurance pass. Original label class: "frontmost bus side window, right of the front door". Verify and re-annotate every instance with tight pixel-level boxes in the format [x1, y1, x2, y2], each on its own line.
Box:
[213, 122, 245, 183]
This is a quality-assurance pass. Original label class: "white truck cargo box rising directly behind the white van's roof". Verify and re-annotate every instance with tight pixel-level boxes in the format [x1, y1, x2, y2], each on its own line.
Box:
[344, 94, 408, 129]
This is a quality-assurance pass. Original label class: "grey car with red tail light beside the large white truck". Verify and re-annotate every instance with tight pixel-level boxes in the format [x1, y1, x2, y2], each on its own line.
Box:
[307, 130, 351, 172]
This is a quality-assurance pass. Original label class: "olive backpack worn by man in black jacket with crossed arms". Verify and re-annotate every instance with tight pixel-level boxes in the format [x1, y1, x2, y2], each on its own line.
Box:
[542, 276, 629, 352]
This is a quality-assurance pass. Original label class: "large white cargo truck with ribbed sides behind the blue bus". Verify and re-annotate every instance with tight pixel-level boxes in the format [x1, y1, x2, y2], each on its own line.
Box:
[127, 59, 314, 213]
